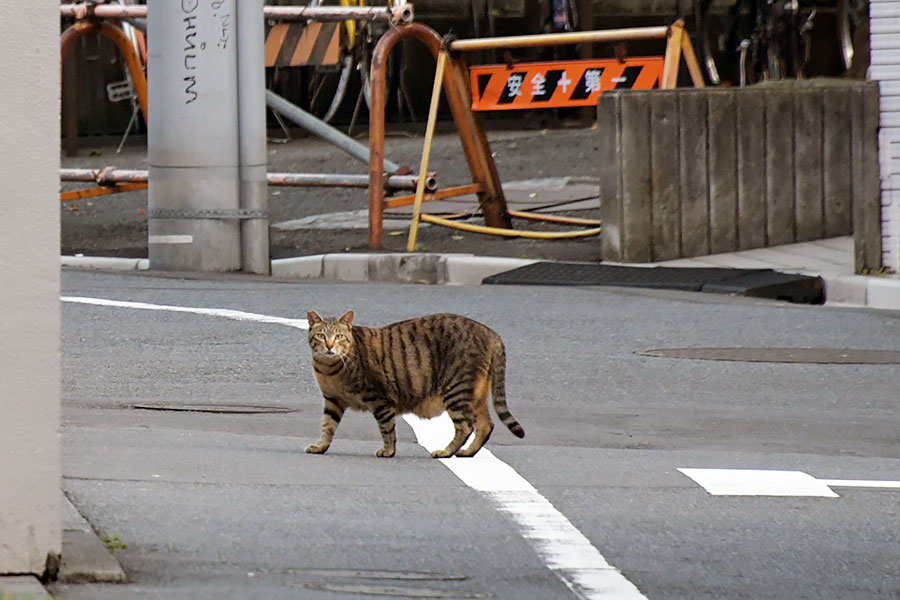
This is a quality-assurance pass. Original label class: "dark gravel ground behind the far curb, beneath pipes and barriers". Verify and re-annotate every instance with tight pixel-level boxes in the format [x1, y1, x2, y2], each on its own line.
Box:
[60, 122, 600, 261]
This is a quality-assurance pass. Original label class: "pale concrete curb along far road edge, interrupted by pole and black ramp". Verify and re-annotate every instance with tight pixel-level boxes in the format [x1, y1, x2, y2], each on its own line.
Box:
[61, 253, 900, 310]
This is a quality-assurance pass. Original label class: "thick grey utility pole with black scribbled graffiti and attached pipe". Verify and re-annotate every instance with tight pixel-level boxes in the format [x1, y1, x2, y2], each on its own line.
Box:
[147, 0, 269, 273]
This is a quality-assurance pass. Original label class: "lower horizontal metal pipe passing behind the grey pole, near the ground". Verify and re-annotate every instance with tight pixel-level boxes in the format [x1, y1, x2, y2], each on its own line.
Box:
[59, 167, 437, 192]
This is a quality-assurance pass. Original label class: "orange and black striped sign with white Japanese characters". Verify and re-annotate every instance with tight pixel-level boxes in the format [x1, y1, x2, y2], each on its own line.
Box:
[469, 56, 663, 110]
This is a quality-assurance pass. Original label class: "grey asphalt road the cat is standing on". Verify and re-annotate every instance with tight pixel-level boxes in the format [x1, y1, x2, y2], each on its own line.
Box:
[53, 272, 900, 600]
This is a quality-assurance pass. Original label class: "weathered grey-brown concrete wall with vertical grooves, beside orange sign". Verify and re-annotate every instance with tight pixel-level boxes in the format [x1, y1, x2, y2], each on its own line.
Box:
[597, 80, 881, 268]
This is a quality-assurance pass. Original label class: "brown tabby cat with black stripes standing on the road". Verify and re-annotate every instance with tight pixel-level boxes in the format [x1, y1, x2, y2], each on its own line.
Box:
[306, 311, 525, 458]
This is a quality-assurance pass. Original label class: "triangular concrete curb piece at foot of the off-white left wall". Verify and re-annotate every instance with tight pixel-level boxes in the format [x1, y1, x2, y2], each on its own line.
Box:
[58, 495, 126, 583]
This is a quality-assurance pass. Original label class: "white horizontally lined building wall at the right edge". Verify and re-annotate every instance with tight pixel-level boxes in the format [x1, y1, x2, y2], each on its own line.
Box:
[869, 0, 900, 273]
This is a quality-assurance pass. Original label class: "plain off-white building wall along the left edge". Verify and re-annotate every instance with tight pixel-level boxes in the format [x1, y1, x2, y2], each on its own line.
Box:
[0, 1, 62, 574]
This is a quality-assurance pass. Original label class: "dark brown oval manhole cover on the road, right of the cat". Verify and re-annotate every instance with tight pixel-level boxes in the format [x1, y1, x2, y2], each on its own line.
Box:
[638, 348, 900, 365]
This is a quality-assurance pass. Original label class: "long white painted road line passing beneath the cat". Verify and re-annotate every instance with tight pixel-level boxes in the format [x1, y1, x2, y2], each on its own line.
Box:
[62, 296, 646, 600]
